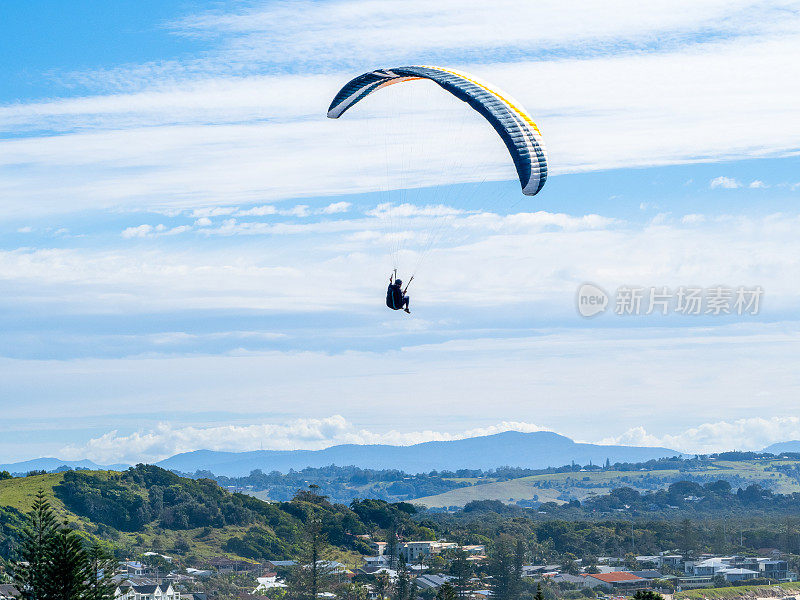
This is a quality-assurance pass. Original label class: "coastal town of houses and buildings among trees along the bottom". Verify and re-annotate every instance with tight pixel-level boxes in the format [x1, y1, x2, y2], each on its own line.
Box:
[0, 540, 797, 600]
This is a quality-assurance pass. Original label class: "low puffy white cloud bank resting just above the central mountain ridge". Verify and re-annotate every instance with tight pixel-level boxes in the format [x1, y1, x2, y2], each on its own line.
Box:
[60, 415, 545, 464]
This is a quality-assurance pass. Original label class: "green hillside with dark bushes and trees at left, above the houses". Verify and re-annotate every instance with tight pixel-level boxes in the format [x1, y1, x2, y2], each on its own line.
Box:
[0, 465, 432, 564]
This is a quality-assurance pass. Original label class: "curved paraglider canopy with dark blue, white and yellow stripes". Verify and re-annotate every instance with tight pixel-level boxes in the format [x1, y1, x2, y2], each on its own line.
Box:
[328, 66, 547, 196]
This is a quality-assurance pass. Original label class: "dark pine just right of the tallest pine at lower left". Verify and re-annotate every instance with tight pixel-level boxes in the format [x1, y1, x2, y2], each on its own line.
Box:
[45, 521, 91, 600]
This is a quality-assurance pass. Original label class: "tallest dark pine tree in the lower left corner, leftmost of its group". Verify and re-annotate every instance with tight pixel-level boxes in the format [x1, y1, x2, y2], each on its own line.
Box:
[15, 490, 58, 600]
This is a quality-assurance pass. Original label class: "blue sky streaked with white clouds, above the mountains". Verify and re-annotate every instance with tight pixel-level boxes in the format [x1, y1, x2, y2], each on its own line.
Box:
[0, 0, 800, 462]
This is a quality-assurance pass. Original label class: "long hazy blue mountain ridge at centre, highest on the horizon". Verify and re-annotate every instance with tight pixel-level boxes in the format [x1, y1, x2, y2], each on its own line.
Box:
[156, 431, 682, 477]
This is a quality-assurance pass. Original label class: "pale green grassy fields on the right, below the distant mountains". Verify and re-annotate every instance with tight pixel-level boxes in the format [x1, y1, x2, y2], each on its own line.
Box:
[414, 460, 800, 507]
